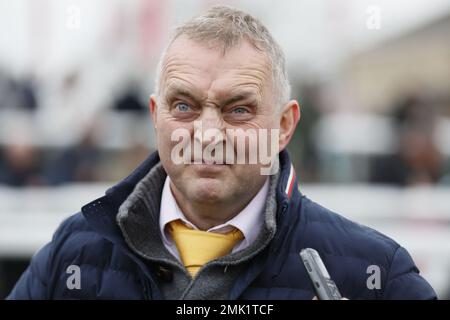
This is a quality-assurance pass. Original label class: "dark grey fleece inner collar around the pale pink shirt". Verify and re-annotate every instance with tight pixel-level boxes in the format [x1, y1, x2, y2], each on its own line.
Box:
[116, 162, 279, 269]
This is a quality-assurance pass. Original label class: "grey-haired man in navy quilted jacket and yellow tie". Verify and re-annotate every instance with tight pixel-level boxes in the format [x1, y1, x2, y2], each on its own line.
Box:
[9, 6, 436, 299]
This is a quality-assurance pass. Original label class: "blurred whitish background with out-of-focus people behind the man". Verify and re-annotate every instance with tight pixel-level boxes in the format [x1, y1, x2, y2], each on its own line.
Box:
[0, 0, 450, 299]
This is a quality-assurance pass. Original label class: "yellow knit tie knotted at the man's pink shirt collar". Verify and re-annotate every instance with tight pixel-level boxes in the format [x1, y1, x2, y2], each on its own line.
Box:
[168, 220, 244, 277]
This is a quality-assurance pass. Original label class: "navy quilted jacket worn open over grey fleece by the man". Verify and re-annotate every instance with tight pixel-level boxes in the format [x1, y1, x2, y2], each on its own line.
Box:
[8, 151, 436, 299]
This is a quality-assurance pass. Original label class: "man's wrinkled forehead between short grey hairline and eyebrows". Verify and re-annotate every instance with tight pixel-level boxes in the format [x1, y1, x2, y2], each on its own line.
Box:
[160, 36, 272, 96]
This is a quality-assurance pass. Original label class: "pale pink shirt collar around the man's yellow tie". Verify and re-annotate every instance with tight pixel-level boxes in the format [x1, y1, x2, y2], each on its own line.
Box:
[159, 176, 269, 260]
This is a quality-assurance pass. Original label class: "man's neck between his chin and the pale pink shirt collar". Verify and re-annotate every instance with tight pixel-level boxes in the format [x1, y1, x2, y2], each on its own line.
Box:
[170, 182, 260, 231]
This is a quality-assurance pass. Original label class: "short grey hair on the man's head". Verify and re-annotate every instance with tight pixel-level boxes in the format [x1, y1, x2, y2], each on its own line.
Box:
[155, 6, 291, 108]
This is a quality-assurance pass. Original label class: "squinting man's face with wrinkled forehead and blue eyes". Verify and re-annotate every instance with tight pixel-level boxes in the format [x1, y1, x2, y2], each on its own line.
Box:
[151, 37, 280, 208]
